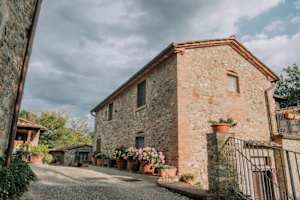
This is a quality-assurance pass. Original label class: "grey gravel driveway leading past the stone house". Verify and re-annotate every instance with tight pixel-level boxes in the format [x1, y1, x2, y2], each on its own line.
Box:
[23, 165, 188, 200]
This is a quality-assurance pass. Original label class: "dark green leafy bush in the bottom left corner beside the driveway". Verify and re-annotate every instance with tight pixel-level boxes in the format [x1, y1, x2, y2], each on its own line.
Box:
[0, 155, 36, 200]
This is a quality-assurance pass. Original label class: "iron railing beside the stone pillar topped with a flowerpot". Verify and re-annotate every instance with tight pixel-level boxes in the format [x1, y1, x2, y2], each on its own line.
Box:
[218, 137, 300, 200]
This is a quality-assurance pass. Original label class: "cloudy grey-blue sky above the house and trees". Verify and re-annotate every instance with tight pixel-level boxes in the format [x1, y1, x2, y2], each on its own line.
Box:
[23, 0, 300, 122]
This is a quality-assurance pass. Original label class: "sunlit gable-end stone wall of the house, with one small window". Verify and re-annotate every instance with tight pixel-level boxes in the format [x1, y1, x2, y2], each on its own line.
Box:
[177, 45, 274, 189]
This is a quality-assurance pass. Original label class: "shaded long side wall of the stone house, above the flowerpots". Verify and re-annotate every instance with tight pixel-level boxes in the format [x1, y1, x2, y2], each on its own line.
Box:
[94, 56, 177, 164]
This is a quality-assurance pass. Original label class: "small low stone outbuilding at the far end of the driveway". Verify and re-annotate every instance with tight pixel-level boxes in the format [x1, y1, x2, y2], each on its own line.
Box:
[49, 144, 92, 167]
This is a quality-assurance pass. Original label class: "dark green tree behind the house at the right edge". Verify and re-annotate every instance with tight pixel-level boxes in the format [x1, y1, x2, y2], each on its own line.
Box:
[275, 64, 300, 107]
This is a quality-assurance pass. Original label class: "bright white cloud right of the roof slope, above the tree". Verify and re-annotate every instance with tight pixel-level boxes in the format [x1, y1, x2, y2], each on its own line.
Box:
[244, 32, 300, 73]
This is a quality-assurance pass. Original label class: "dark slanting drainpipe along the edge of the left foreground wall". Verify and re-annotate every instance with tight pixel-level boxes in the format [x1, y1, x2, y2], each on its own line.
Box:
[5, 0, 42, 167]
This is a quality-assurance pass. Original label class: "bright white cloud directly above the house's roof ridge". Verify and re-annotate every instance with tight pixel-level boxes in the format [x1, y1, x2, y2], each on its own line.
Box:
[190, 0, 284, 37]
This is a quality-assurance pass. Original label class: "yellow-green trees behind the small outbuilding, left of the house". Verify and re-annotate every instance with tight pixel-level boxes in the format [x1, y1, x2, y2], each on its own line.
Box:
[21, 111, 92, 148]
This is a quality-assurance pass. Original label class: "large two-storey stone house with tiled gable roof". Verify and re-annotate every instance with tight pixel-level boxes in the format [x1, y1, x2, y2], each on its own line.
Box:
[91, 37, 278, 189]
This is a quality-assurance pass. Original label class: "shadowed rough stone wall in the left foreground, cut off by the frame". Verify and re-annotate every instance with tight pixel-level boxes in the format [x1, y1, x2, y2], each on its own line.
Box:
[0, 0, 37, 154]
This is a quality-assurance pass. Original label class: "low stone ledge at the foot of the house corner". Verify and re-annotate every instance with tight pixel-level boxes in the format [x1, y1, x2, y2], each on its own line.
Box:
[157, 182, 209, 200]
